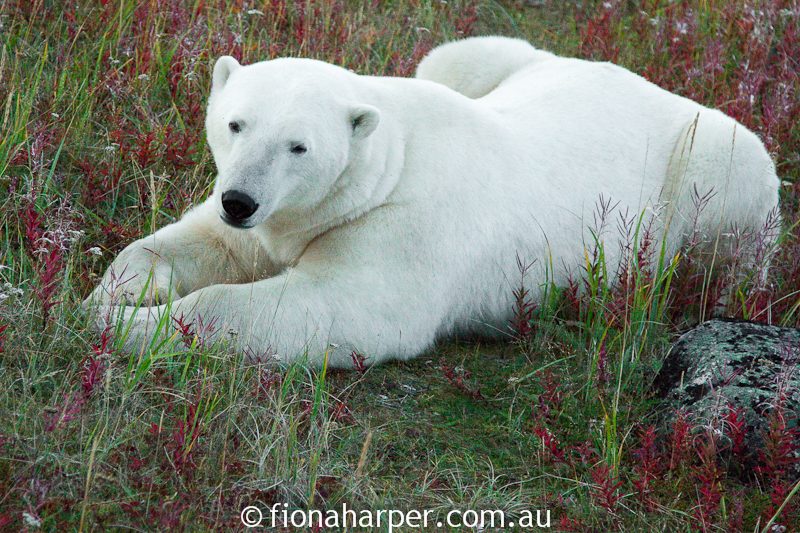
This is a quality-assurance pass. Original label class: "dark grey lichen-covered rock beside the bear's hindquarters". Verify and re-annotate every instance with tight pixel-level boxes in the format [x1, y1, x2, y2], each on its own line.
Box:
[656, 320, 800, 470]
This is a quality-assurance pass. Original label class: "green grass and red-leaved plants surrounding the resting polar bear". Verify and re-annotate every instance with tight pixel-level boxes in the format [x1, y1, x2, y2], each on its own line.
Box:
[0, 0, 800, 531]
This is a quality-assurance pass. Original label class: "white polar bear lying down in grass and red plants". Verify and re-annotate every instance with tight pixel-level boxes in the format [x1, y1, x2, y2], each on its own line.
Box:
[87, 37, 778, 367]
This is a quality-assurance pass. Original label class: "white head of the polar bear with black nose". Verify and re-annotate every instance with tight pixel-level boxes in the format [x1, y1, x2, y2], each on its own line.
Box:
[206, 56, 380, 228]
